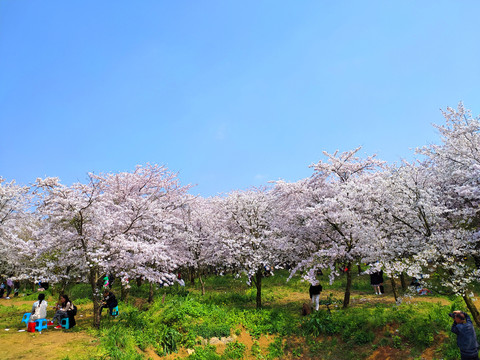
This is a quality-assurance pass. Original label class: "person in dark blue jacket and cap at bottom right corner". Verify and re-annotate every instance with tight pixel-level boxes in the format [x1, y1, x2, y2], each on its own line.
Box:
[448, 310, 478, 360]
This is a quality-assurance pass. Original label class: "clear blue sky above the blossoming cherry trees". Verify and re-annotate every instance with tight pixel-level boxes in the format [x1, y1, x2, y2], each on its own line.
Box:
[0, 0, 480, 196]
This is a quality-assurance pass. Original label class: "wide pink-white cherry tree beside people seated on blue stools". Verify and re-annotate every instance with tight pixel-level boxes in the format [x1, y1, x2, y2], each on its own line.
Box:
[37, 165, 188, 327]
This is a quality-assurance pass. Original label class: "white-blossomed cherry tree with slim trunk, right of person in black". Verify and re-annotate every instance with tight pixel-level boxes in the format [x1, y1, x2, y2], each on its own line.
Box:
[364, 162, 443, 299]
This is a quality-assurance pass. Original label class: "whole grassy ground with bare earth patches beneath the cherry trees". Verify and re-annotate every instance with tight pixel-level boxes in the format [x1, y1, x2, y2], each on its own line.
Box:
[0, 272, 472, 360]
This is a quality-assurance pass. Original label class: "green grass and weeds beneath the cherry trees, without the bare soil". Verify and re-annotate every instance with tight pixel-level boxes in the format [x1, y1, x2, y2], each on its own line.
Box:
[6, 268, 465, 360]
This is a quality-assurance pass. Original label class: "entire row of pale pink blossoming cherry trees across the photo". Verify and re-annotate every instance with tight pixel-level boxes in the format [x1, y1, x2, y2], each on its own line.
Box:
[0, 104, 480, 326]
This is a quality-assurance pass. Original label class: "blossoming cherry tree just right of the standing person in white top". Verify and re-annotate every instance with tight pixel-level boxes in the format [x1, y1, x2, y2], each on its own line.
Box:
[278, 148, 383, 307]
